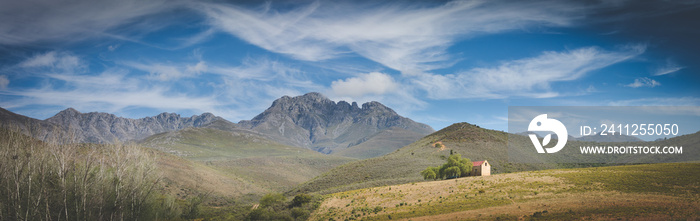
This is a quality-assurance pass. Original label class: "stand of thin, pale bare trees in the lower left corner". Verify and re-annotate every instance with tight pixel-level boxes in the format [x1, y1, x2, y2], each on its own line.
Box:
[0, 129, 165, 220]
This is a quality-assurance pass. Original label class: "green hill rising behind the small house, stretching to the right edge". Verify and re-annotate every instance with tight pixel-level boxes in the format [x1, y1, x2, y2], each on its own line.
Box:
[290, 123, 700, 194]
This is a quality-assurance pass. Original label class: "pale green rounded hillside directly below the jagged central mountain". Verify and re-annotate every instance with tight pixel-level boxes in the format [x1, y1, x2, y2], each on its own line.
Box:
[141, 128, 354, 194]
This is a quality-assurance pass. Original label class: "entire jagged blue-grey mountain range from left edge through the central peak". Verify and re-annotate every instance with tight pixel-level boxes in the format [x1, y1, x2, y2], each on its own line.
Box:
[0, 92, 434, 158]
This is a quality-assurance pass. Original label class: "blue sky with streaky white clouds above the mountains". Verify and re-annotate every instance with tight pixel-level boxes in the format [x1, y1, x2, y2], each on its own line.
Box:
[0, 0, 700, 130]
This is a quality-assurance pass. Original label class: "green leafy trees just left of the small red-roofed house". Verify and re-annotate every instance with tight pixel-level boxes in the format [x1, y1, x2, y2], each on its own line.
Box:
[420, 154, 472, 180]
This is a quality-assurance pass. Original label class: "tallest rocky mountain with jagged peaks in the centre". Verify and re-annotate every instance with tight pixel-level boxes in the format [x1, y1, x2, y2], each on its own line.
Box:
[238, 92, 434, 154]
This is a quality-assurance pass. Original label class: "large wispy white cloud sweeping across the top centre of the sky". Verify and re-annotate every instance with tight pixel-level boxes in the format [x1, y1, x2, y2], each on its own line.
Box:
[197, 1, 580, 71]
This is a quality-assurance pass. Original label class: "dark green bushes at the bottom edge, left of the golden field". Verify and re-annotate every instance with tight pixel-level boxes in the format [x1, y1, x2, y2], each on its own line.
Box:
[246, 193, 320, 221]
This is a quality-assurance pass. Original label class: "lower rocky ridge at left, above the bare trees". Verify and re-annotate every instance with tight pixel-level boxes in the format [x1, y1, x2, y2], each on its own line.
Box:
[0, 108, 235, 143]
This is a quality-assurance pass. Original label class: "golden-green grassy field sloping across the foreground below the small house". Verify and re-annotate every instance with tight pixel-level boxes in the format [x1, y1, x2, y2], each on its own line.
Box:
[310, 163, 700, 220]
